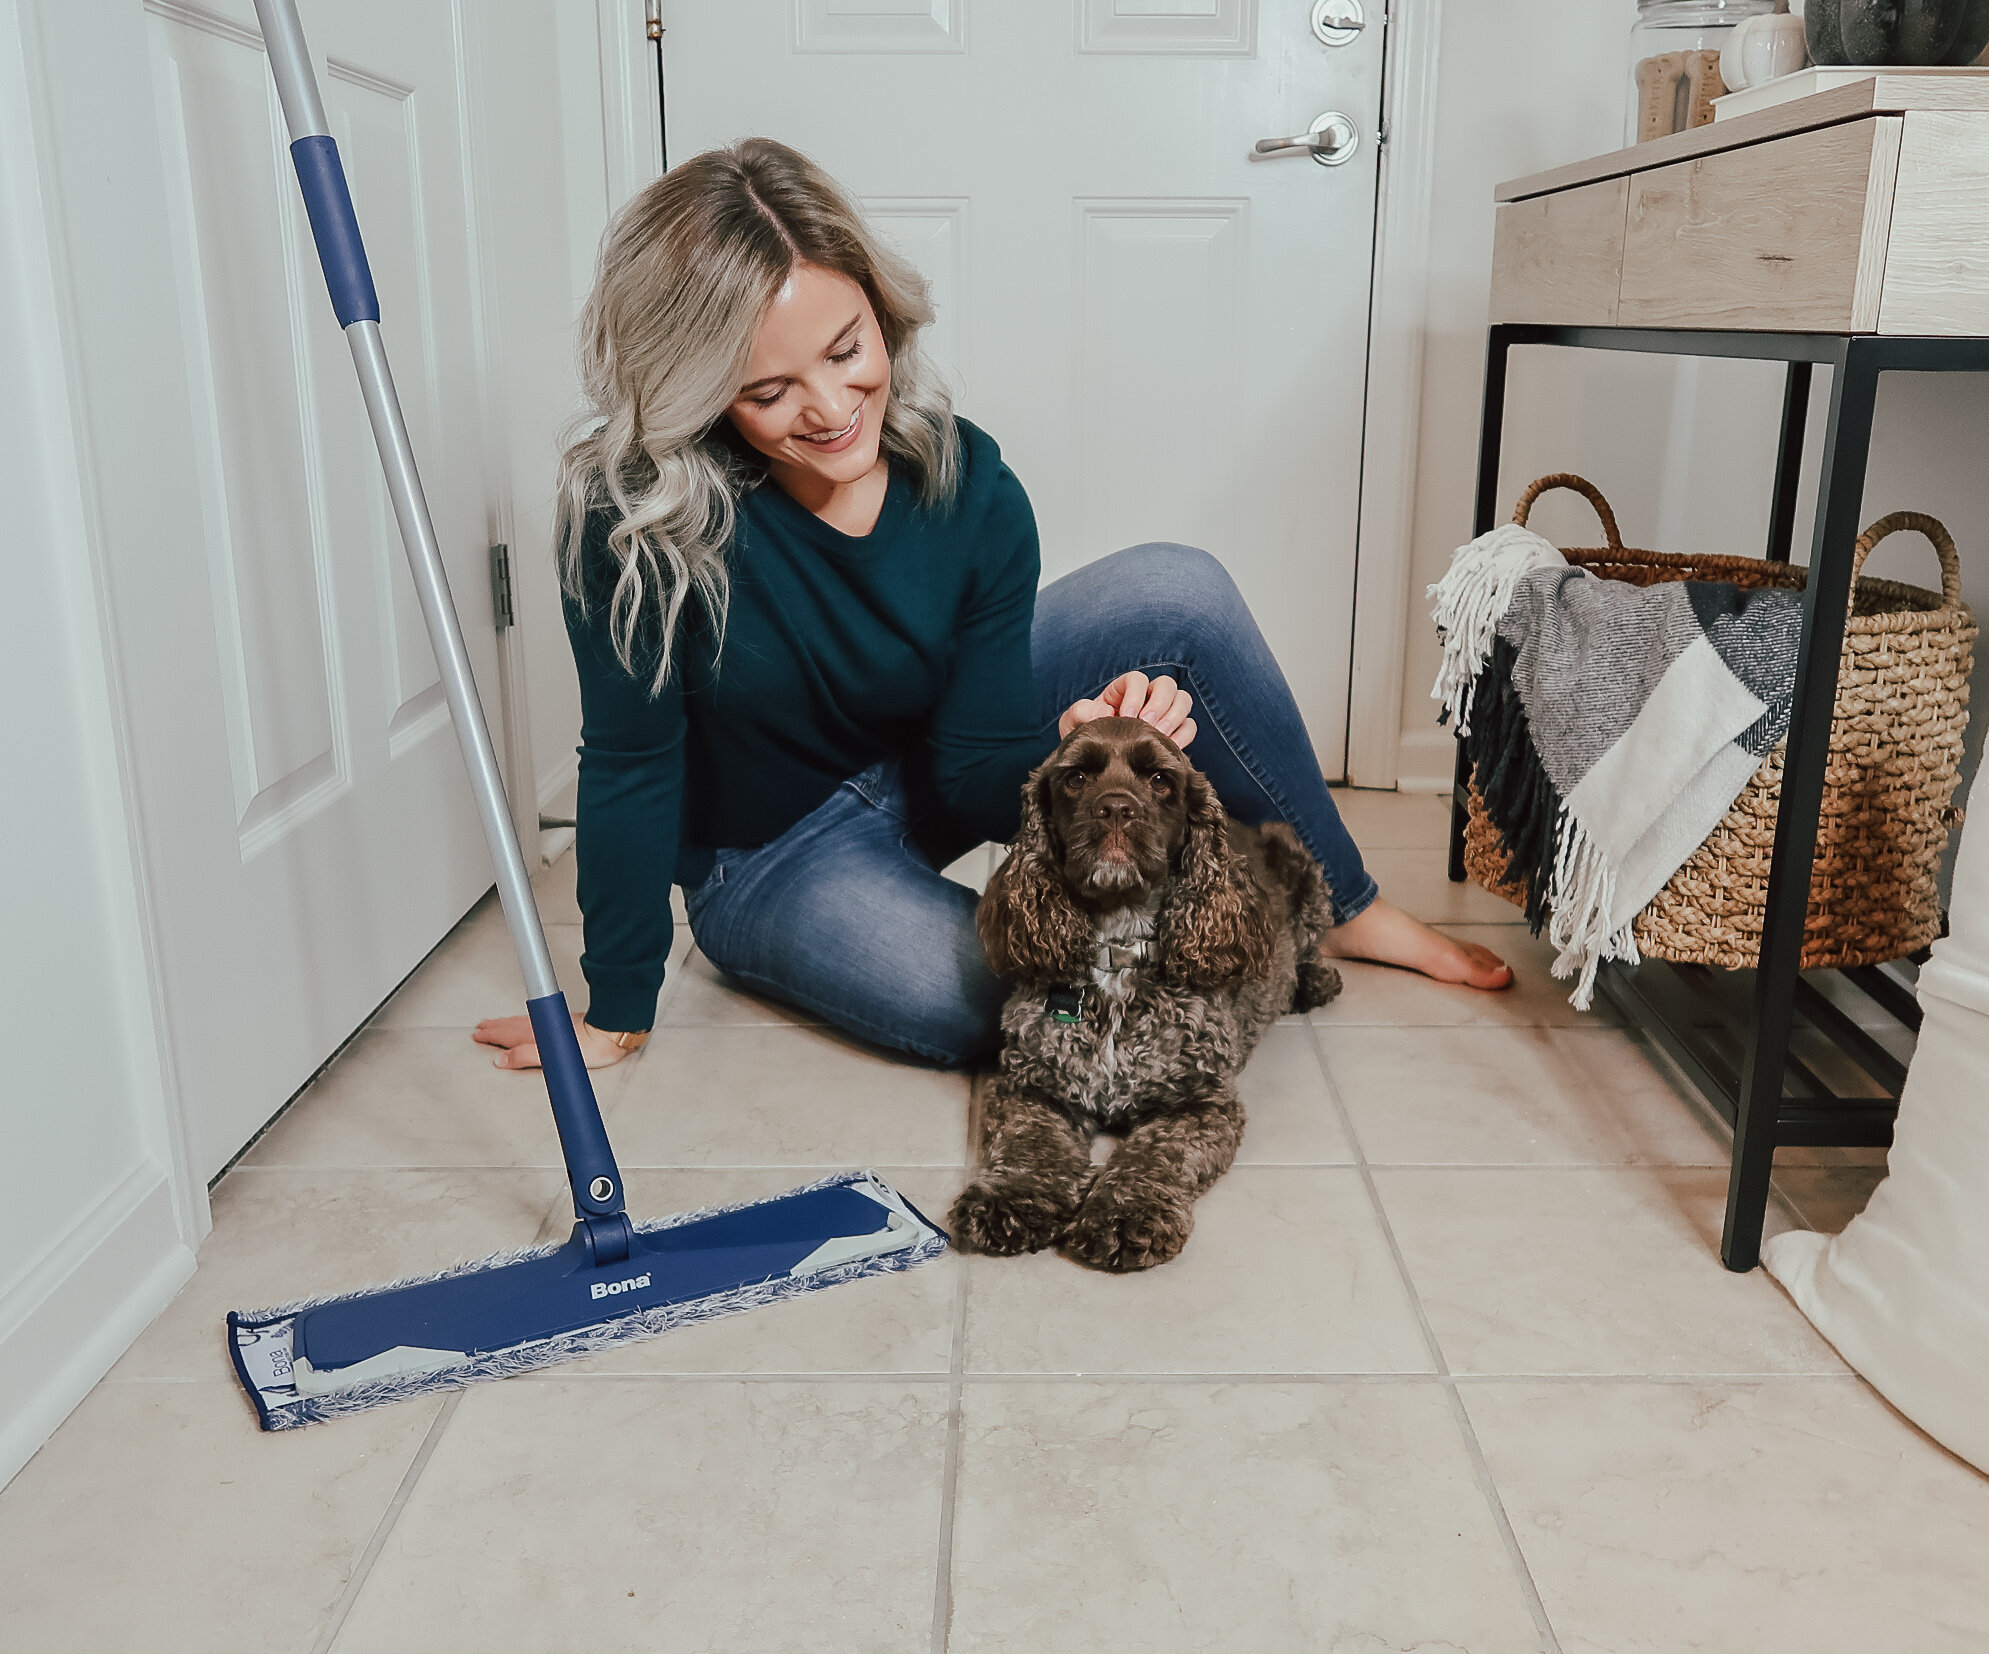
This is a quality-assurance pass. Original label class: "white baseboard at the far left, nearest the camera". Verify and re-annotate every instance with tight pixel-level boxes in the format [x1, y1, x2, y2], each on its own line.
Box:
[0, 1159, 193, 1487]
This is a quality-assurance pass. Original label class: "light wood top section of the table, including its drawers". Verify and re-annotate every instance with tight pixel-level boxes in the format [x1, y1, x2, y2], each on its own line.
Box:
[1492, 70, 1989, 336]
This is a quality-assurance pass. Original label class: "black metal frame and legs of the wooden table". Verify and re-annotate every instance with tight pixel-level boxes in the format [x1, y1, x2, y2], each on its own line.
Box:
[1450, 322, 1989, 1270]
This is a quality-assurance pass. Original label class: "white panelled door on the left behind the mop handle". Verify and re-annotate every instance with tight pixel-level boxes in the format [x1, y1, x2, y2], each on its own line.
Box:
[44, 0, 529, 1177]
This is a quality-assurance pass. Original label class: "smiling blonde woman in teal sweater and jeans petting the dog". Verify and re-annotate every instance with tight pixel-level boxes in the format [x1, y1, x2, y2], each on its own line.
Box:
[475, 139, 1512, 1068]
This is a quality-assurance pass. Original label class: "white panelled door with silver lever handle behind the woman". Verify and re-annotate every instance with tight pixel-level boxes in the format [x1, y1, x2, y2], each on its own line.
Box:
[664, 0, 1382, 775]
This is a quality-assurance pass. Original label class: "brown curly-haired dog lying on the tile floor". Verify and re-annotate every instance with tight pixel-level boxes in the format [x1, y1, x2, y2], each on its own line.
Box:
[953, 718, 1341, 1270]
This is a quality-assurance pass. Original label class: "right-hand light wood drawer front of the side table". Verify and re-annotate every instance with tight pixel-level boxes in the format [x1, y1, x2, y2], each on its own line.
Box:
[1615, 115, 1901, 332]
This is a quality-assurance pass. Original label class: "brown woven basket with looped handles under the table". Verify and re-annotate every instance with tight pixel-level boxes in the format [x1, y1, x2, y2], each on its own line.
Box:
[1464, 475, 1975, 970]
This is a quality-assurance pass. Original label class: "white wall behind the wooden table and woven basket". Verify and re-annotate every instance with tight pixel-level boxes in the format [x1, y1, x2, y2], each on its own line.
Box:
[1400, 0, 1989, 827]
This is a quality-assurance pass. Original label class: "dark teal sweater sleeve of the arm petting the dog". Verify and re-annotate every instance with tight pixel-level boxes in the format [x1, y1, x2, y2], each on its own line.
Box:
[929, 465, 1054, 843]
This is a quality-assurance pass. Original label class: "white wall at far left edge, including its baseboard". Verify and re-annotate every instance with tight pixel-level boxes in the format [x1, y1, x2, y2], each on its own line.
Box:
[0, 0, 199, 1483]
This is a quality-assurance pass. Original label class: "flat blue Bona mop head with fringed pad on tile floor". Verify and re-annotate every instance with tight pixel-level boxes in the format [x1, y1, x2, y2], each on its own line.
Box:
[229, 1171, 947, 1429]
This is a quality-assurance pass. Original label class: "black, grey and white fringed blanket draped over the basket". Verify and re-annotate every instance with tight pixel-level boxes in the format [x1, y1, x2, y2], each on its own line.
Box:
[1430, 523, 1802, 1010]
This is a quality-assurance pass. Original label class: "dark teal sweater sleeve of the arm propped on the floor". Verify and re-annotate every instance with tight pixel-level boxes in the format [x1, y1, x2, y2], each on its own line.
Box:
[567, 523, 684, 1034]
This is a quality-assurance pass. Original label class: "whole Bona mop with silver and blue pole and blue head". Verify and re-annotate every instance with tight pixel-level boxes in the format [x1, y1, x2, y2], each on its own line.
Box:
[227, 0, 947, 1429]
